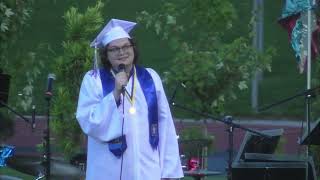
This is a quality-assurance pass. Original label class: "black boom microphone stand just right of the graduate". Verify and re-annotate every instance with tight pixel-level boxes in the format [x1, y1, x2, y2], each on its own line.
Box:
[170, 101, 271, 180]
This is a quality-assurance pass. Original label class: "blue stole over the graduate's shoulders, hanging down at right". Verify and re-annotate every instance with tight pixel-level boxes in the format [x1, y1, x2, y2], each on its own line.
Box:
[100, 66, 159, 150]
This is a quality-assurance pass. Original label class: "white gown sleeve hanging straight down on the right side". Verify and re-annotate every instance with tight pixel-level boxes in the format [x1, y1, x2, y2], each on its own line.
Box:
[148, 68, 183, 179]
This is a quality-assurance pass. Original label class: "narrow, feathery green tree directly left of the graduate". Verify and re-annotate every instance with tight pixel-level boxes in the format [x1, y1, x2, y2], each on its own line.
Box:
[52, 1, 104, 155]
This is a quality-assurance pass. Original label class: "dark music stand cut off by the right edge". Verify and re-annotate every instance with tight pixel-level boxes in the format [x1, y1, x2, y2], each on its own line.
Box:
[300, 119, 320, 145]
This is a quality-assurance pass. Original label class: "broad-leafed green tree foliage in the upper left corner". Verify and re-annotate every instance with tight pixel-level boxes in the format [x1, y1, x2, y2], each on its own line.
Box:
[0, 0, 50, 111]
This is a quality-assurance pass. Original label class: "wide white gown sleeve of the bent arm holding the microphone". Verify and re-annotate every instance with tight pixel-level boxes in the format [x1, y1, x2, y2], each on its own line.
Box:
[76, 72, 122, 142]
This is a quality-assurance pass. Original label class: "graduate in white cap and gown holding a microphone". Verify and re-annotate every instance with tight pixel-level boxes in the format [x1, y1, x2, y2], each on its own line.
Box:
[76, 19, 183, 180]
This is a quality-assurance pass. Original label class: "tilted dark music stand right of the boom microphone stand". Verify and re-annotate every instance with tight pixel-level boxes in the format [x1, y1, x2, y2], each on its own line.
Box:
[233, 129, 283, 163]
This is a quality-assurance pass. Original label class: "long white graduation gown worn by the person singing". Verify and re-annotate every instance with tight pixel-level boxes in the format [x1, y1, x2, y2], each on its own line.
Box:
[76, 68, 183, 180]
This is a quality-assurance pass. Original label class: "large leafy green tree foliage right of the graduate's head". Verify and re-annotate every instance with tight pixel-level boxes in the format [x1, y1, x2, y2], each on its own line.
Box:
[137, 0, 274, 114]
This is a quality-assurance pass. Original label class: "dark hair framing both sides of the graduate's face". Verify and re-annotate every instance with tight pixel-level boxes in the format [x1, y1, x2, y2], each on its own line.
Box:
[99, 38, 139, 69]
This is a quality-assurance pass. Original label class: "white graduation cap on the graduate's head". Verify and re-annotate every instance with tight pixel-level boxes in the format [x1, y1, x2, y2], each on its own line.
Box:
[90, 19, 137, 48]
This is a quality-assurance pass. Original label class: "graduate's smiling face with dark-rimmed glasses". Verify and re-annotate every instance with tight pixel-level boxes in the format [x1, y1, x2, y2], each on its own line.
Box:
[107, 38, 134, 69]
